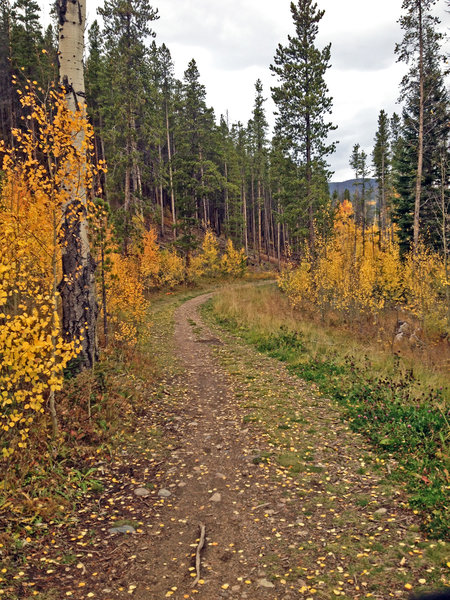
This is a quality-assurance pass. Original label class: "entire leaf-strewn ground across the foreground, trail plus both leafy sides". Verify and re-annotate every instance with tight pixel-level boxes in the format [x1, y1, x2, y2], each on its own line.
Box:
[4, 286, 449, 600]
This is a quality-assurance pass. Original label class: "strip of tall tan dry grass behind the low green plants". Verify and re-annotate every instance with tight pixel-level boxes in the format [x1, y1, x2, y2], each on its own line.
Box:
[214, 283, 450, 396]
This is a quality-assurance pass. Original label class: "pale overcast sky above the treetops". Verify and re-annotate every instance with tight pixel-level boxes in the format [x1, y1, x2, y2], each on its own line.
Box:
[41, 0, 449, 181]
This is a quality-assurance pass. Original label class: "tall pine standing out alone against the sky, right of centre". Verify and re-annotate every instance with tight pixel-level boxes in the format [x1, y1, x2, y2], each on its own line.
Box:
[270, 0, 335, 250]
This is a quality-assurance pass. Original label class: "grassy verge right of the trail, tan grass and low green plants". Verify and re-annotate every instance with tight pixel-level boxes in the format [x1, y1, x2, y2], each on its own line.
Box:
[207, 285, 450, 538]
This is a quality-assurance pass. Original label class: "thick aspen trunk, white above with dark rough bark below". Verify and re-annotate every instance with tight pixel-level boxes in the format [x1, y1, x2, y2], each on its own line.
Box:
[57, 0, 98, 369]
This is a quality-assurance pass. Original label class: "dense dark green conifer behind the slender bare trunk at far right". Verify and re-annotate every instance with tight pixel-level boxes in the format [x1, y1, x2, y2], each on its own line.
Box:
[393, 21, 449, 253]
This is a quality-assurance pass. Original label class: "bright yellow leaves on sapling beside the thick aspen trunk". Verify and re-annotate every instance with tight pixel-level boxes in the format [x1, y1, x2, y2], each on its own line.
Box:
[0, 84, 95, 458]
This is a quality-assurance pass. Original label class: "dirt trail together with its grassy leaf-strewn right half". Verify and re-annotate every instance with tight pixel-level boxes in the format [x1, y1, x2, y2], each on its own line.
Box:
[128, 296, 445, 600]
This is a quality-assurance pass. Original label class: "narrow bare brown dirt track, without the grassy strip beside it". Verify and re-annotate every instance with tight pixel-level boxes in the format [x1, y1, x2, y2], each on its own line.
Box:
[137, 296, 296, 600]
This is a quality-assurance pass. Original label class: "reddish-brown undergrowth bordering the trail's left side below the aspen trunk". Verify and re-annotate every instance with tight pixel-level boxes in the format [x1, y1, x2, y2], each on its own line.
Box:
[0, 290, 198, 556]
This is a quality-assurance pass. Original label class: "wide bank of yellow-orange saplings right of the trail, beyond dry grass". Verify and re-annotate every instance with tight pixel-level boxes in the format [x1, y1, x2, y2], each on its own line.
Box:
[279, 203, 449, 330]
